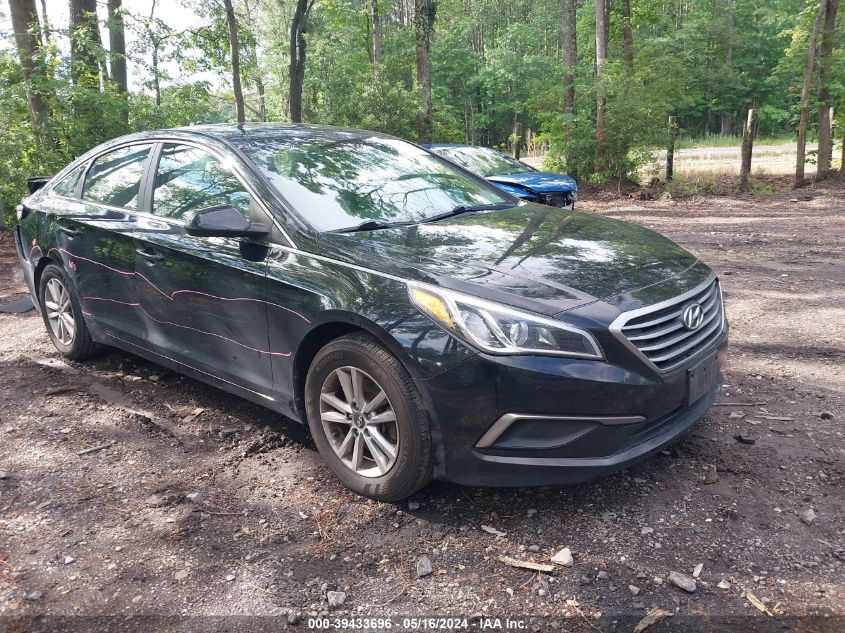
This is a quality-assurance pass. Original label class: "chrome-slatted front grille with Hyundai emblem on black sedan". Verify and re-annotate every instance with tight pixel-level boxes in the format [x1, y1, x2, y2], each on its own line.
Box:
[611, 279, 725, 372]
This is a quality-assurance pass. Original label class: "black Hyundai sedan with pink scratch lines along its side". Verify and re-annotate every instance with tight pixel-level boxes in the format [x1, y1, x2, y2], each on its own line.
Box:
[15, 125, 727, 500]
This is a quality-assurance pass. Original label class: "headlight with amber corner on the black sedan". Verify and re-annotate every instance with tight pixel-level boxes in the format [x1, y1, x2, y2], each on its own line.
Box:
[408, 282, 603, 360]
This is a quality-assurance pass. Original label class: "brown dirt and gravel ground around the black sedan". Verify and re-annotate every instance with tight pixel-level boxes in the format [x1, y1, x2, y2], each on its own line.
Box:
[0, 180, 845, 631]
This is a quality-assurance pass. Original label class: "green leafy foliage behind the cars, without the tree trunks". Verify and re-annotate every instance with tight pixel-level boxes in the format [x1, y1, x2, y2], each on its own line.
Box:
[0, 0, 845, 227]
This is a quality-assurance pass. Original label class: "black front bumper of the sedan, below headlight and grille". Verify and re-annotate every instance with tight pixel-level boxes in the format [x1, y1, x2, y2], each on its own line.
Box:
[419, 333, 727, 486]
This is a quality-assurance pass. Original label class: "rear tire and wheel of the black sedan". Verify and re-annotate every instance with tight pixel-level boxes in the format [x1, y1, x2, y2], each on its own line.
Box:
[38, 264, 100, 360]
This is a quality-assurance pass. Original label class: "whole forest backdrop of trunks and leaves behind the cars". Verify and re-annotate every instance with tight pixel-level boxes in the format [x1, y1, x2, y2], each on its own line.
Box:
[0, 0, 845, 223]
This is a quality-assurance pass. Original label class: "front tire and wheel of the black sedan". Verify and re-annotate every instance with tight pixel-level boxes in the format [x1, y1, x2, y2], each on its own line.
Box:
[305, 334, 432, 501]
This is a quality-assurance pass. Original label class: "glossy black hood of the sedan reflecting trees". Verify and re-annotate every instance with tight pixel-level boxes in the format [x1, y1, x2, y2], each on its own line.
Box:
[323, 203, 710, 314]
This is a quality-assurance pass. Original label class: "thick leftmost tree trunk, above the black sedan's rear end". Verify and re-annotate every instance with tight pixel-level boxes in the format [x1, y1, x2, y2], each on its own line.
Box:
[9, 0, 50, 148]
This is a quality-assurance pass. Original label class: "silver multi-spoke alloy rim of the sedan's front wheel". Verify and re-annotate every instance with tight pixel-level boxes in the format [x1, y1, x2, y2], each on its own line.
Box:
[320, 367, 399, 477]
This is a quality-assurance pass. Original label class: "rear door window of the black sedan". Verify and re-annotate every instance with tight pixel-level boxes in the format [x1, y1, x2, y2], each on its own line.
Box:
[82, 144, 152, 211]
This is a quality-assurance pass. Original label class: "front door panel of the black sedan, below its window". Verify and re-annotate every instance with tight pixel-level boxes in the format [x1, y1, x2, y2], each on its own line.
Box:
[135, 218, 276, 397]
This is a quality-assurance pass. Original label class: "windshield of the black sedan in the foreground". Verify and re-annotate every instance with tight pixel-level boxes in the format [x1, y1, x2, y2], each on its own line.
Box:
[241, 135, 510, 231]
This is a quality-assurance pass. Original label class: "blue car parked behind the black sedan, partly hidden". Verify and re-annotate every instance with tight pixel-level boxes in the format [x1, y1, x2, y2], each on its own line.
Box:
[424, 144, 578, 209]
